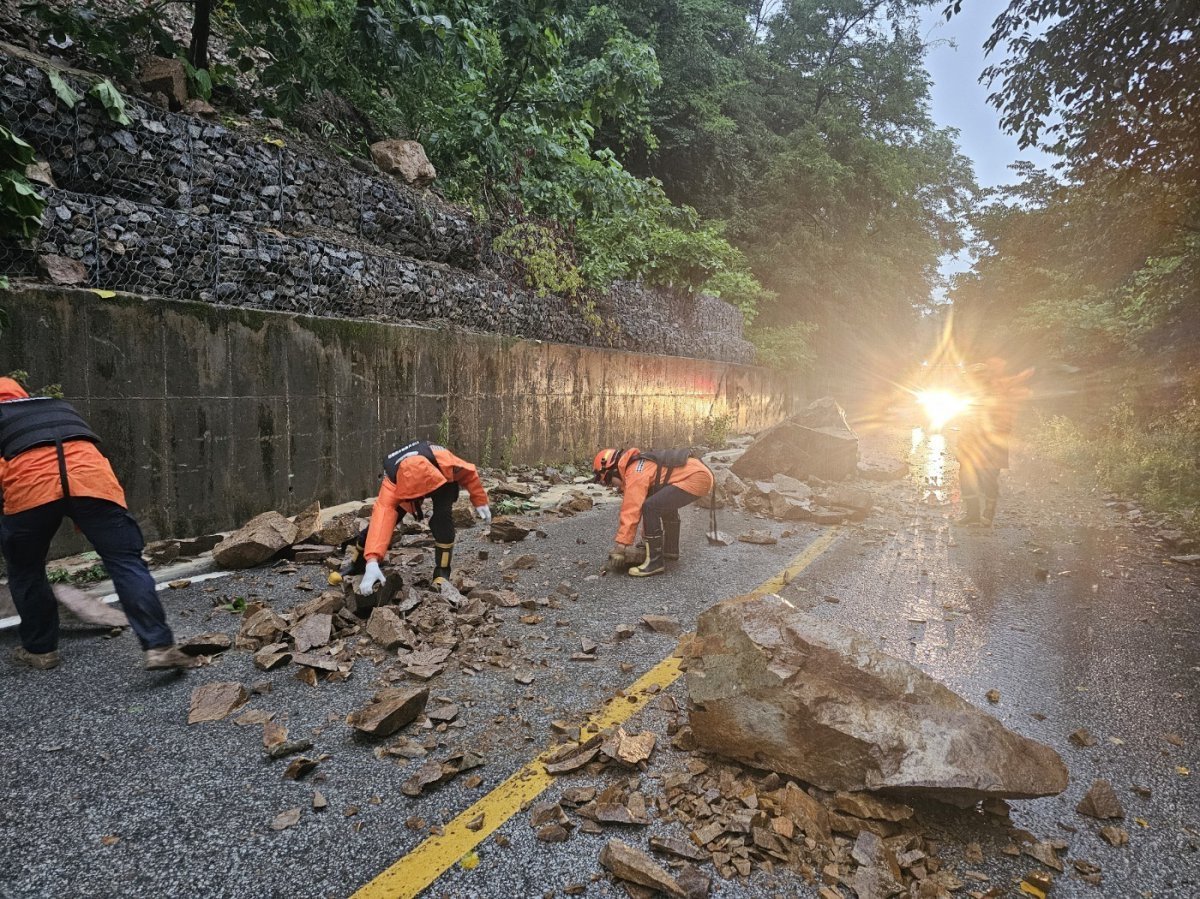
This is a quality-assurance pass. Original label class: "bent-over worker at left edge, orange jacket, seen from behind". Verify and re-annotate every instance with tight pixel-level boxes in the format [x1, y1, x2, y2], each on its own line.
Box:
[0, 378, 193, 670]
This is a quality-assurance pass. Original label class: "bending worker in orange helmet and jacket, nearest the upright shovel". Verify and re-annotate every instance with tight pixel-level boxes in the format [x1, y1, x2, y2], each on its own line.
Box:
[592, 446, 713, 577]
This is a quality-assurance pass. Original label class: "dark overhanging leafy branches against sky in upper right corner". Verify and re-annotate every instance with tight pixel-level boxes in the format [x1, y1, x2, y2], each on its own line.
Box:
[974, 0, 1200, 186]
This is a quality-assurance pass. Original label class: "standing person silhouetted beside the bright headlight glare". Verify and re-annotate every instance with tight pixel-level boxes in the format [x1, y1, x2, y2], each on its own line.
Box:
[956, 358, 1033, 526]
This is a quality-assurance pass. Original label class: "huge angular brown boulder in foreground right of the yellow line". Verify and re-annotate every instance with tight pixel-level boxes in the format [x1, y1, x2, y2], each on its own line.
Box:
[688, 595, 1067, 802]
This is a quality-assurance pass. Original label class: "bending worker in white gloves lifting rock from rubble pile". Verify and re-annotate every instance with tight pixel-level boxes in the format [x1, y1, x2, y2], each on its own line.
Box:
[359, 440, 492, 595]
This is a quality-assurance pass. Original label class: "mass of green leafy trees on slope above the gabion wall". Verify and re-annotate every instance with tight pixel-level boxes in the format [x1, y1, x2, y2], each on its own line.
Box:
[18, 0, 973, 352]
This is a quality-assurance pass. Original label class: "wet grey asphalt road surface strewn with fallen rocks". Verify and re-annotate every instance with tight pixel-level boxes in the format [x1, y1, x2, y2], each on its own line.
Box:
[0, 427, 1200, 899]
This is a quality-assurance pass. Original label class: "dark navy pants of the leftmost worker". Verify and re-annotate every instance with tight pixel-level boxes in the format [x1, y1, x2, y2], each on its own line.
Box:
[0, 497, 175, 653]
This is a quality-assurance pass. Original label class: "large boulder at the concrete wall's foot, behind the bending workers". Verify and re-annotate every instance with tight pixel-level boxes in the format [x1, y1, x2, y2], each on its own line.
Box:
[732, 396, 858, 481]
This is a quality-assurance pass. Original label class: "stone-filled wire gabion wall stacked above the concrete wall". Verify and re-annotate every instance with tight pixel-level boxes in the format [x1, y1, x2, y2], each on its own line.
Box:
[0, 53, 754, 362]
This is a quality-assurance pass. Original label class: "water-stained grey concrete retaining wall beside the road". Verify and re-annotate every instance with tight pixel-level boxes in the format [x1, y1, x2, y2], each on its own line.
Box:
[0, 289, 798, 538]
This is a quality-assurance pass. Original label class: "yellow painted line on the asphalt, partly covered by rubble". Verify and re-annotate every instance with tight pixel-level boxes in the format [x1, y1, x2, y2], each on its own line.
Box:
[353, 529, 840, 899]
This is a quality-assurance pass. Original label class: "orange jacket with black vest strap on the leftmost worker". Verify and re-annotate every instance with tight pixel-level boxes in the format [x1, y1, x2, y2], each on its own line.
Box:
[0, 378, 125, 515]
